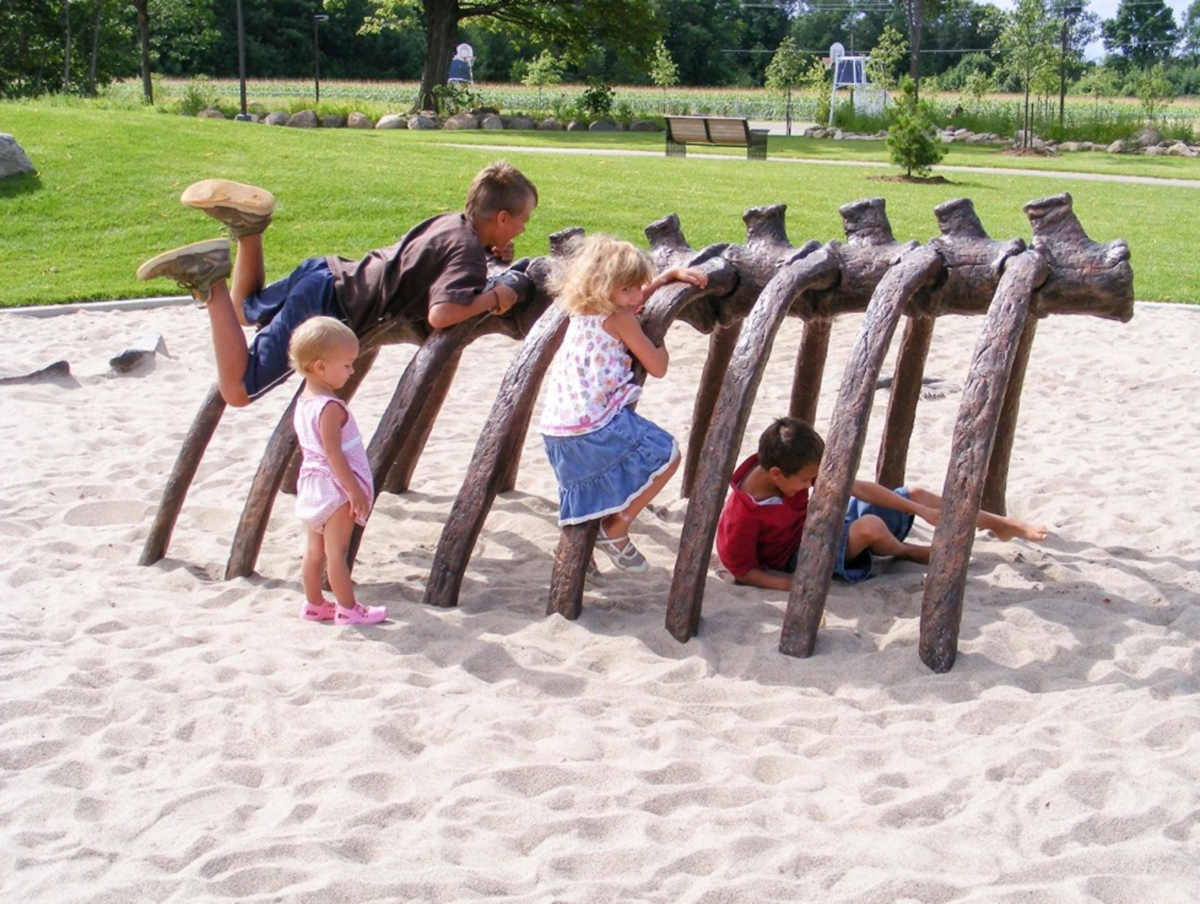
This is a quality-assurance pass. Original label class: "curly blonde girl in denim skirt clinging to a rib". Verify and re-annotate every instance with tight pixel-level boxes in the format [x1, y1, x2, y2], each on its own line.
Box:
[539, 235, 708, 571]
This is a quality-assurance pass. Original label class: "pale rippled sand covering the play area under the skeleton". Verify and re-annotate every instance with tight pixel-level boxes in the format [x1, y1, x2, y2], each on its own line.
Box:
[0, 305, 1200, 904]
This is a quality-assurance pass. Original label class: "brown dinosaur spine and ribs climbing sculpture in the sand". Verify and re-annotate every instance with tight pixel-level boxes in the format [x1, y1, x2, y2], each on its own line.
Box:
[142, 194, 1133, 671]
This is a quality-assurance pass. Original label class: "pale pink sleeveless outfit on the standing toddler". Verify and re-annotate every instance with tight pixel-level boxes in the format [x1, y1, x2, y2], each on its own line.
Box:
[293, 395, 374, 533]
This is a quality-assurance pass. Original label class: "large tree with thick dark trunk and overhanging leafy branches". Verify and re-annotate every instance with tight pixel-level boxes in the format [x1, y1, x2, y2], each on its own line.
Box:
[364, 0, 660, 109]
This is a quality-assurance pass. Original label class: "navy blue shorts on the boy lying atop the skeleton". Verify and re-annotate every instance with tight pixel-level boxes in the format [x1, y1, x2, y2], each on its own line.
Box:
[241, 257, 347, 400]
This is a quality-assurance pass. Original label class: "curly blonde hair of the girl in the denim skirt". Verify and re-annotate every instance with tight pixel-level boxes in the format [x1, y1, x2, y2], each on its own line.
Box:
[552, 235, 655, 313]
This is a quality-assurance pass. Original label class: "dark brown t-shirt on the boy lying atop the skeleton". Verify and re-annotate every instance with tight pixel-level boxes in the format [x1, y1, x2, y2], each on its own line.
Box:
[325, 214, 487, 333]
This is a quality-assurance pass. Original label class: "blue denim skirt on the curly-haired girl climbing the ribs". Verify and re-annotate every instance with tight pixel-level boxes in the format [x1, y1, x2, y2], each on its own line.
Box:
[542, 408, 679, 525]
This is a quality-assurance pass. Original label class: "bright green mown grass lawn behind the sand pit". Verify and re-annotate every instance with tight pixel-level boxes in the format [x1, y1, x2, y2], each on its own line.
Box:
[7, 103, 1200, 306]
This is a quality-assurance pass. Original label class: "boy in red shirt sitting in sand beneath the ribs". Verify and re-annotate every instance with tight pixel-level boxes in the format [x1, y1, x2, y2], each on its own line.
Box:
[716, 418, 1049, 592]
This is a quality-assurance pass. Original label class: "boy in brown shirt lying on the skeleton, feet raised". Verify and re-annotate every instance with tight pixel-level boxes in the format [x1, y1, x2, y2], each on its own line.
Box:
[138, 162, 538, 407]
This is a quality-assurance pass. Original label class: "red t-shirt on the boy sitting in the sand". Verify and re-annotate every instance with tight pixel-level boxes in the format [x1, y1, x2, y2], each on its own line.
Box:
[716, 455, 809, 577]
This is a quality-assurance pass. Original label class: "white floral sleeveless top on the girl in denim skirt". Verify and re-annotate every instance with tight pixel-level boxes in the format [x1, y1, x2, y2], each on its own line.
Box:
[539, 313, 642, 436]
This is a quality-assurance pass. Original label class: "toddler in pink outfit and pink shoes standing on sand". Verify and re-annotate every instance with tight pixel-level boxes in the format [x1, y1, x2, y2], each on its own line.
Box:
[288, 317, 388, 624]
